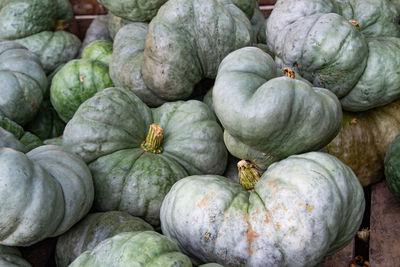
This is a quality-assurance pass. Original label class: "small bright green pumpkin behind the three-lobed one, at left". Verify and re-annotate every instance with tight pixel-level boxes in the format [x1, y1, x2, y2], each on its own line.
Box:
[50, 59, 113, 122]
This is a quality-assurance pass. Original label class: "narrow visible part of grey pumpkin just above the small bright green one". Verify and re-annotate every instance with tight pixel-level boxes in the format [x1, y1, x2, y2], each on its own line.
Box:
[79, 15, 112, 55]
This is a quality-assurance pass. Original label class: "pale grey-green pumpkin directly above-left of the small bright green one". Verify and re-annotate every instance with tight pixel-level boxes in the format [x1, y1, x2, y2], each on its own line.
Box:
[15, 31, 81, 73]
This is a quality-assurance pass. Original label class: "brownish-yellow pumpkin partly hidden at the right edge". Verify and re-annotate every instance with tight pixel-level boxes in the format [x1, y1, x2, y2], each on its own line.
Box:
[325, 100, 400, 186]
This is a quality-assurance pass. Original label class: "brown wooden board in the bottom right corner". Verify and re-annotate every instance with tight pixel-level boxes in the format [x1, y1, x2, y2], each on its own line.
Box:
[369, 181, 400, 267]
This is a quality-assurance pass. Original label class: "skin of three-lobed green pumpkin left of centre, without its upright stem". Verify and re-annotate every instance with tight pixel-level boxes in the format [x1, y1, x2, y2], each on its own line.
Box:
[63, 88, 227, 226]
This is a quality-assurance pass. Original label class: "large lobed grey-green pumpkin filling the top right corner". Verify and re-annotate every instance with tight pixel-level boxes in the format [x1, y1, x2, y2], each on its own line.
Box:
[266, 0, 400, 111]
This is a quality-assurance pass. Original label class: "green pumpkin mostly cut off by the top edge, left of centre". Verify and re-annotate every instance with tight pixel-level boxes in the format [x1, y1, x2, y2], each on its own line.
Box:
[99, 0, 167, 21]
